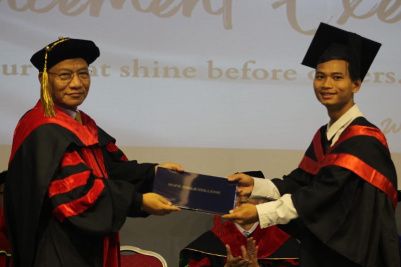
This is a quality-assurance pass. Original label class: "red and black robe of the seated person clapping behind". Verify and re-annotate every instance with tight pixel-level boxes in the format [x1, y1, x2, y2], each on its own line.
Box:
[179, 216, 299, 267]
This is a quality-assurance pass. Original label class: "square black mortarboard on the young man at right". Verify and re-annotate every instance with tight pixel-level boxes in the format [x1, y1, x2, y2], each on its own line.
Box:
[302, 23, 381, 81]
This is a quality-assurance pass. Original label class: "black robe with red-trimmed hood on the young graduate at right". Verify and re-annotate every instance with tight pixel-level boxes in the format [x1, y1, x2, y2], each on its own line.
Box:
[273, 117, 400, 267]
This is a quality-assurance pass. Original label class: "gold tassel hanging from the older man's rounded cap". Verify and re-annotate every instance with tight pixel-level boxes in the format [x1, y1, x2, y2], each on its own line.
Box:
[40, 37, 69, 117]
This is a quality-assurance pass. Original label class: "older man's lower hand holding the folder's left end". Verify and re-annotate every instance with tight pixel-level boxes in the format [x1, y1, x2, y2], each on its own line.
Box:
[142, 193, 180, 215]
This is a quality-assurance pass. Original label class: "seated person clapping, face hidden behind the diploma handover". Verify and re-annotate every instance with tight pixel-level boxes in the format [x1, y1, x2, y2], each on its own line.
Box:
[179, 171, 299, 267]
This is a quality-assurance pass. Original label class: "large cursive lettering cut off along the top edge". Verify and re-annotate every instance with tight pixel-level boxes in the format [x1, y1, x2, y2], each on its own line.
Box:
[5, 0, 401, 29]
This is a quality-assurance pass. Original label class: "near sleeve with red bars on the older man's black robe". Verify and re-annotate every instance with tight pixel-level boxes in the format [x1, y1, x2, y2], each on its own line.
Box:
[48, 143, 154, 234]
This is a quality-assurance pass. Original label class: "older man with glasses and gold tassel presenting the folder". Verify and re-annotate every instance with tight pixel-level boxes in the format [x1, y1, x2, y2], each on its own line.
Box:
[5, 38, 182, 267]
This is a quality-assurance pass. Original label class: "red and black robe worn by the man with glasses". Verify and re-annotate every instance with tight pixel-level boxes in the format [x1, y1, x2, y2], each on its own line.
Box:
[5, 102, 154, 267]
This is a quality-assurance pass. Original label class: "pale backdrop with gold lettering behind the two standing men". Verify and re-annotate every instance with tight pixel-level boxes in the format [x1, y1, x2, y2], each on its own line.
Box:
[0, 0, 401, 266]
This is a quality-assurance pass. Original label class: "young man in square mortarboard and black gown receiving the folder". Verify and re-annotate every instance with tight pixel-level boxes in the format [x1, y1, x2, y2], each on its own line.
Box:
[224, 23, 400, 267]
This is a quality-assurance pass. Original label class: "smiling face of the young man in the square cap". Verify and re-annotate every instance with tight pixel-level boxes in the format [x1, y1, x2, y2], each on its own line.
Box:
[313, 59, 361, 120]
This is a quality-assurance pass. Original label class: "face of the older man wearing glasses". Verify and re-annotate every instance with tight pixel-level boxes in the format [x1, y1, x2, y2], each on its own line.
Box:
[43, 58, 90, 110]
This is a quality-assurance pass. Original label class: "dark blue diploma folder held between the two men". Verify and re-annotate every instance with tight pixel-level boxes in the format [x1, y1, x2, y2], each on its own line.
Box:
[153, 168, 236, 214]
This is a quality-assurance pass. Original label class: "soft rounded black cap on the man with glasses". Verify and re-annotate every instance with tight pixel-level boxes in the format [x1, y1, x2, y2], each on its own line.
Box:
[31, 38, 100, 72]
